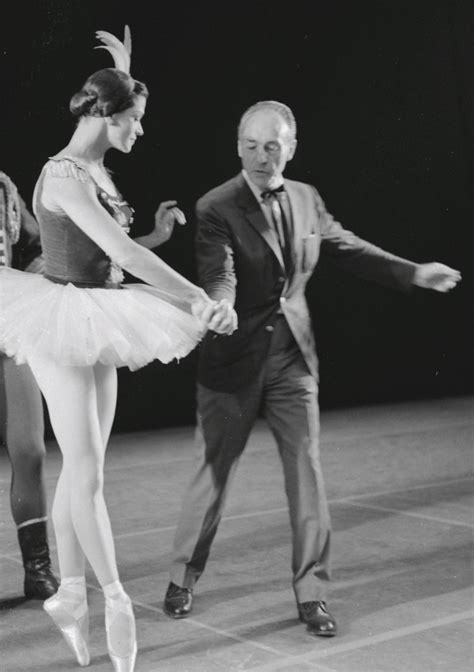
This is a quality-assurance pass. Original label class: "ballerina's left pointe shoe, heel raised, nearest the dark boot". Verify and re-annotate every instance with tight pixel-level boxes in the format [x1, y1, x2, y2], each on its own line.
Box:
[43, 591, 90, 667]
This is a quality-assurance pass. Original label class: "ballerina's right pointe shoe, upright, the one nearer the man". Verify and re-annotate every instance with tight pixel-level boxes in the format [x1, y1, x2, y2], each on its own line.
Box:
[105, 595, 137, 672]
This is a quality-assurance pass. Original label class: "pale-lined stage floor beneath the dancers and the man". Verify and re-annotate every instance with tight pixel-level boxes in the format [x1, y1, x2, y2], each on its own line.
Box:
[0, 398, 474, 672]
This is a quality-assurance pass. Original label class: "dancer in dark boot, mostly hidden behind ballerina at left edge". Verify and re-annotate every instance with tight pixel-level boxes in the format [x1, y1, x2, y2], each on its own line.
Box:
[0, 171, 58, 600]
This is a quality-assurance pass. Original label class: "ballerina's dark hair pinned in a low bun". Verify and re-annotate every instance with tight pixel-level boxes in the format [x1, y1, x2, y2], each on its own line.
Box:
[69, 68, 148, 118]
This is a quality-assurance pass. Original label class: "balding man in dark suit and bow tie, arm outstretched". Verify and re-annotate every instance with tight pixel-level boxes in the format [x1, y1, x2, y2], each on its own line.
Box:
[164, 101, 460, 636]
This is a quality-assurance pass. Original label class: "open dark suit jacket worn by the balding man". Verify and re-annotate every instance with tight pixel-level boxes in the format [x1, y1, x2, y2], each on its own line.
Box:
[196, 174, 416, 392]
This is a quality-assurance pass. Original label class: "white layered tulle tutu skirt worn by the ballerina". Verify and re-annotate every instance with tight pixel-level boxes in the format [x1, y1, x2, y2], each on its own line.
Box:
[0, 268, 204, 371]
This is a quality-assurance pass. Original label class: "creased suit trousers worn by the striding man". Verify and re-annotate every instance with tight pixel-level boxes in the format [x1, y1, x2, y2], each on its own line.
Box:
[170, 315, 330, 602]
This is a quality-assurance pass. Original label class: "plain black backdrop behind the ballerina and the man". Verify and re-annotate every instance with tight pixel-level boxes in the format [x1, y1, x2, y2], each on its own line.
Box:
[0, 0, 474, 431]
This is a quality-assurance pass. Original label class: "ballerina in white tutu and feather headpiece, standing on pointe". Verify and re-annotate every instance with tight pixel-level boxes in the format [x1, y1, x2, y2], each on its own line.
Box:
[0, 27, 219, 672]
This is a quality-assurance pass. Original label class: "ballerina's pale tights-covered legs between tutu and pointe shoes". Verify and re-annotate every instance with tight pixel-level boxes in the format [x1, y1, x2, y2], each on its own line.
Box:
[29, 356, 118, 586]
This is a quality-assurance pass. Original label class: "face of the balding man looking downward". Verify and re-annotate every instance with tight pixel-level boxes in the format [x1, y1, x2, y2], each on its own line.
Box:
[237, 110, 296, 190]
